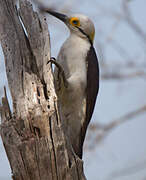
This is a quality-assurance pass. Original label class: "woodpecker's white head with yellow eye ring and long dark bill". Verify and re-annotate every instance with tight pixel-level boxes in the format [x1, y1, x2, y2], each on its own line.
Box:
[47, 11, 95, 44]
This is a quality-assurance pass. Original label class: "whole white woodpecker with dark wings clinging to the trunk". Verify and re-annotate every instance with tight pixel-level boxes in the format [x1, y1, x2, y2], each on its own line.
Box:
[42, 9, 99, 159]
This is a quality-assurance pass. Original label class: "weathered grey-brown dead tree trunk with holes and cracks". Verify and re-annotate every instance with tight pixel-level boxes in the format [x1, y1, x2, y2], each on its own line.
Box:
[0, 0, 85, 180]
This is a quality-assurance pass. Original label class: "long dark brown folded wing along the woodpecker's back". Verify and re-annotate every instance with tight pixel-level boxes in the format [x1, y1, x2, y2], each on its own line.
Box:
[79, 45, 99, 158]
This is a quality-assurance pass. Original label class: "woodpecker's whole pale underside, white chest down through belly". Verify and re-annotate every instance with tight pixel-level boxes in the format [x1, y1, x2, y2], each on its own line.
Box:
[58, 37, 90, 139]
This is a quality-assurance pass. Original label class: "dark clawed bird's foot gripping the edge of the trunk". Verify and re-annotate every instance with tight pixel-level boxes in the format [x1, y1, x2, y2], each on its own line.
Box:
[47, 57, 68, 88]
